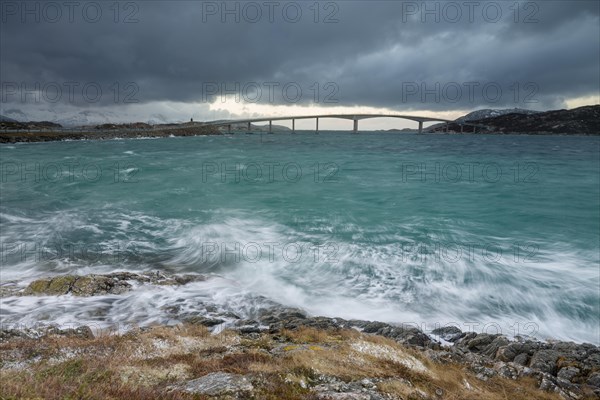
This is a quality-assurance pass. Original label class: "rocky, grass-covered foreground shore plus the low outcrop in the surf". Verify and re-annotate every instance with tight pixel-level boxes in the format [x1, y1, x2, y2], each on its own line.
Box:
[0, 272, 600, 399]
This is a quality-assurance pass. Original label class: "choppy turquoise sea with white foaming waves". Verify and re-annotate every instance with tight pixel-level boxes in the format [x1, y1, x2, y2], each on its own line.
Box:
[0, 132, 600, 344]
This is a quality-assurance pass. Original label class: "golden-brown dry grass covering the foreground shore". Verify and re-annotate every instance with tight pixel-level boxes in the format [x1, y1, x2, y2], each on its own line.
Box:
[0, 325, 559, 400]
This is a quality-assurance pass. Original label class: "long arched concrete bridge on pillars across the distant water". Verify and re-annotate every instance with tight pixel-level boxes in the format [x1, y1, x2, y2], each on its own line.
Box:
[204, 114, 474, 133]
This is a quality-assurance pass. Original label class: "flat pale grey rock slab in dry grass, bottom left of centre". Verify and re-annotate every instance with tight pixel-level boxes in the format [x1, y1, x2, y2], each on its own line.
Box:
[171, 372, 254, 396]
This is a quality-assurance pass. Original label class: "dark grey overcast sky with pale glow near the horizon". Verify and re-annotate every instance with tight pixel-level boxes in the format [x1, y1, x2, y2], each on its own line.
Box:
[0, 0, 600, 128]
